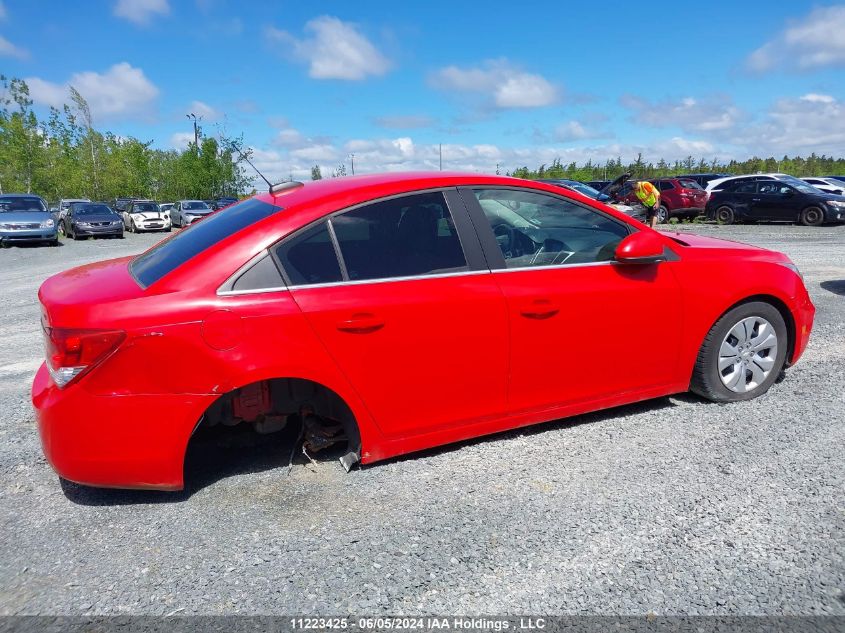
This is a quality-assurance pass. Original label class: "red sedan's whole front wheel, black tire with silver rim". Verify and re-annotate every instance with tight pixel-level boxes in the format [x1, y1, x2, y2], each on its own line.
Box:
[690, 301, 789, 402]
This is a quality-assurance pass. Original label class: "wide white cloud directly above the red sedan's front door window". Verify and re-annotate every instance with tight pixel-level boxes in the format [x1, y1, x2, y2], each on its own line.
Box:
[430, 59, 560, 108]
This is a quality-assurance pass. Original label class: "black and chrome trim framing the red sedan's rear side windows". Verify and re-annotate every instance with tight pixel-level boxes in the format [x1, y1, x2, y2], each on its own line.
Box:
[268, 187, 490, 292]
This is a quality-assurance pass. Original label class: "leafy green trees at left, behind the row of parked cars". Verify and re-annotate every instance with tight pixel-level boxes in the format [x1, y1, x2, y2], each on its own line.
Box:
[0, 75, 252, 200]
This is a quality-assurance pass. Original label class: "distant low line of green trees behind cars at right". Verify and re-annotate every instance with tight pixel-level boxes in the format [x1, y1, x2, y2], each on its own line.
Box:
[509, 154, 845, 182]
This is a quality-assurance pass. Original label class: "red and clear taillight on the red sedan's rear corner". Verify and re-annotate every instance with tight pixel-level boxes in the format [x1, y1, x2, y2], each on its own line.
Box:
[44, 326, 126, 388]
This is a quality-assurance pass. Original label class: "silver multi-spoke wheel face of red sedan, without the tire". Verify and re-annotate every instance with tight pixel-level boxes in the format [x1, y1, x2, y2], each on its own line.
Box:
[719, 316, 778, 393]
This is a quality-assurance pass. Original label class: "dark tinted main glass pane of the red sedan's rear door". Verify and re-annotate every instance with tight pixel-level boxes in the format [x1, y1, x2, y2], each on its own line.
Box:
[331, 192, 468, 281]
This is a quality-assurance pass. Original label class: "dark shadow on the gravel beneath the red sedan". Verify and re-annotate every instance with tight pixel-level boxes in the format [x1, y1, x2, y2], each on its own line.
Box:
[61, 393, 704, 506]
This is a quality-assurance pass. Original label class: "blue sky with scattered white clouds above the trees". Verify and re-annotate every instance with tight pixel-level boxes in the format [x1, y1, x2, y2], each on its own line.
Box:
[0, 0, 845, 181]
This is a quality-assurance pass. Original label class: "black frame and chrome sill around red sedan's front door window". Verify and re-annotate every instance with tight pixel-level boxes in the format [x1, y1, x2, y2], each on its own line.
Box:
[458, 184, 637, 273]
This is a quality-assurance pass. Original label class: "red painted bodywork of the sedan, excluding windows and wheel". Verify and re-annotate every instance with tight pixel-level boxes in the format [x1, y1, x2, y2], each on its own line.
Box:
[32, 173, 814, 490]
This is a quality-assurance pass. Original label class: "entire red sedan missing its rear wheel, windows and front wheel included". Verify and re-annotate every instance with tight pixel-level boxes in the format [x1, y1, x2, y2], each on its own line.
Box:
[32, 173, 814, 490]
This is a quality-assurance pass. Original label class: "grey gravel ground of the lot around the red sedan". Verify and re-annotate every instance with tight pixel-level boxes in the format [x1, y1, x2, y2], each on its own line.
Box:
[0, 225, 845, 615]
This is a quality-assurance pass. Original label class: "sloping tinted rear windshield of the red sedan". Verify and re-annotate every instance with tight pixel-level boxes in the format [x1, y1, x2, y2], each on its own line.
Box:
[129, 198, 281, 288]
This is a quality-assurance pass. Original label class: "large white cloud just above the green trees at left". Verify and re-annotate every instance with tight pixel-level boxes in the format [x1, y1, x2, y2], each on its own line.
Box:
[26, 62, 159, 119]
